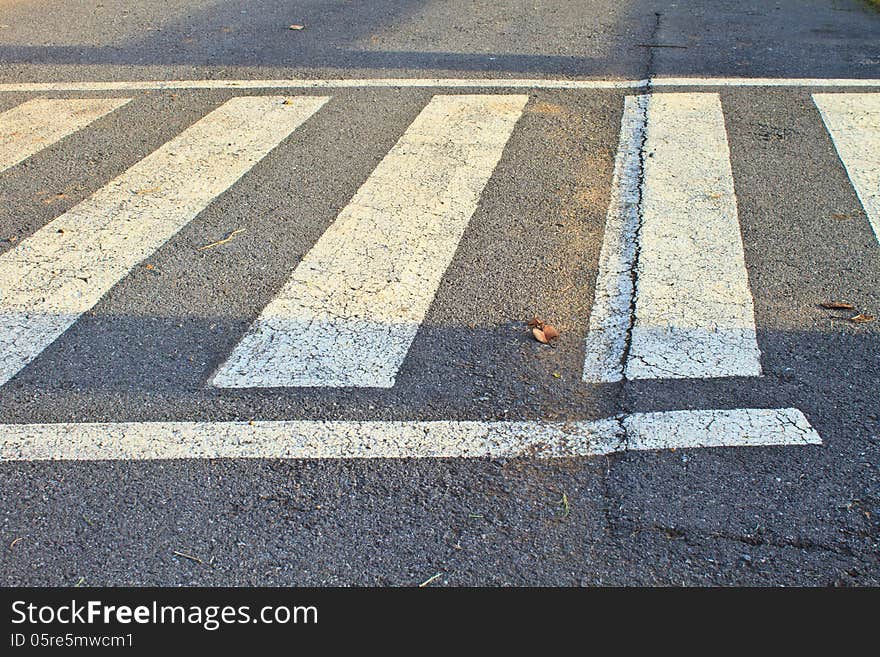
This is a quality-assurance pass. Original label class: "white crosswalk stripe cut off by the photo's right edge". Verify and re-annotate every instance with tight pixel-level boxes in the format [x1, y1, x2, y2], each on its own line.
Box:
[813, 93, 880, 241]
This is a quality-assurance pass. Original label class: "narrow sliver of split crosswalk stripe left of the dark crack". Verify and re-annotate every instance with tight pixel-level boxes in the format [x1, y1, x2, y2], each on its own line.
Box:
[583, 96, 648, 383]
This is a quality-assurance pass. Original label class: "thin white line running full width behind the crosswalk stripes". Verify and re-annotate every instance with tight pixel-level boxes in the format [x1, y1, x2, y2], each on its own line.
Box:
[0, 78, 880, 93]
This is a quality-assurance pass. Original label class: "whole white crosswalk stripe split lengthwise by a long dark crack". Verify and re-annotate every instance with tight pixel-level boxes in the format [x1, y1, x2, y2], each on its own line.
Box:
[583, 93, 761, 381]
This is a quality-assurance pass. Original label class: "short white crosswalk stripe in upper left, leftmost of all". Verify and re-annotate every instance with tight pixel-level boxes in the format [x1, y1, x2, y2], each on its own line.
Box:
[0, 98, 131, 171]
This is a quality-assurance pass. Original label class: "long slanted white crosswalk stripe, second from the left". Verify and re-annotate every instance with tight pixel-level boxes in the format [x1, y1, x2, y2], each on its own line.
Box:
[0, 96, 327, 384]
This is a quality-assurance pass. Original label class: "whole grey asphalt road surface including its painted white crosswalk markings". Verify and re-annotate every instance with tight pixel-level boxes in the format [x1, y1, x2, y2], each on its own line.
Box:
[0, 0, 880, 586]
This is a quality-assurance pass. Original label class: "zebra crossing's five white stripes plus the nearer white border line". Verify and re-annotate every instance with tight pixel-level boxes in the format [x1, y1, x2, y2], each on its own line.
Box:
[0, 82, 880, 460]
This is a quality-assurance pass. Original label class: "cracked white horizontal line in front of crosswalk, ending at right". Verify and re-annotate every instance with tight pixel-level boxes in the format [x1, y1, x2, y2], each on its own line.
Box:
[0, 408, 822, 461]
